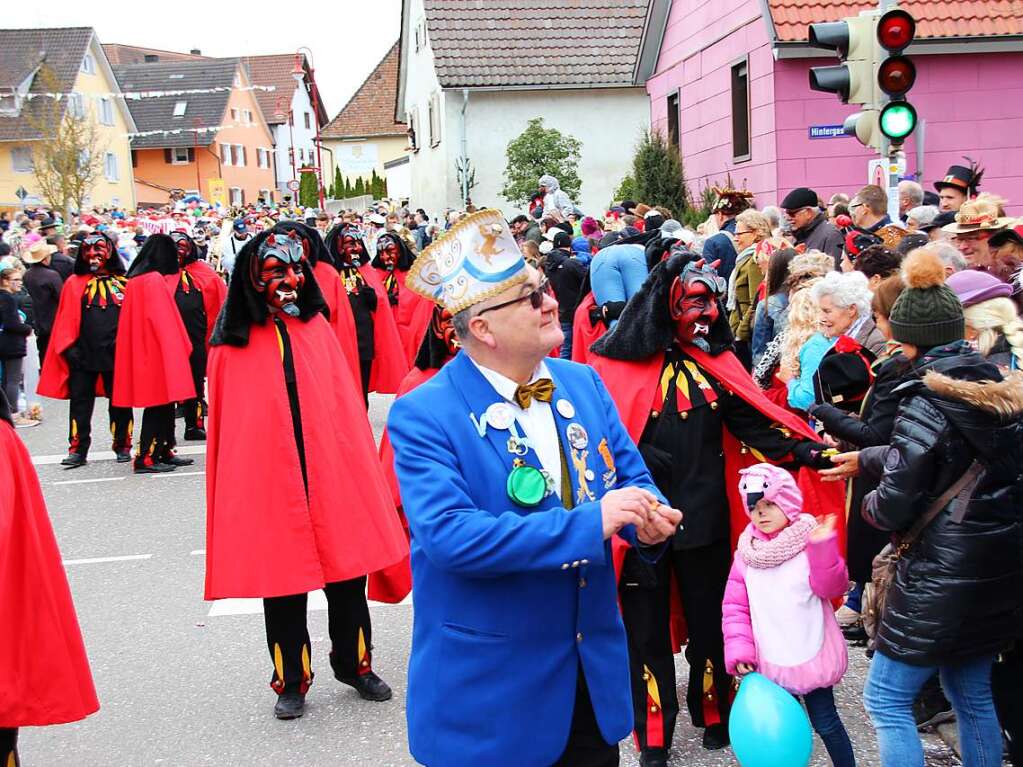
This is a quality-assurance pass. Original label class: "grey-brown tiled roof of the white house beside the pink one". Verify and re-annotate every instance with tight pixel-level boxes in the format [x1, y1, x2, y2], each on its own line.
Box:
[425, 0, 650, 88]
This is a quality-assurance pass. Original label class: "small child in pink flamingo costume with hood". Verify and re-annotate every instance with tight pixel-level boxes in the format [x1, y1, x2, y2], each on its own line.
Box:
[721, 463, 856, 767]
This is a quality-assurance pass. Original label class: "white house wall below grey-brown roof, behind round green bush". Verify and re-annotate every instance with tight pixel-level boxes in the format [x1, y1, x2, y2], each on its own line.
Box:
[462, 88, 650, 216]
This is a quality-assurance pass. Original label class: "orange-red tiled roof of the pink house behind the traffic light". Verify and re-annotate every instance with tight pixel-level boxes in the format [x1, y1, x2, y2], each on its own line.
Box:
[767, 0, 1023, 42]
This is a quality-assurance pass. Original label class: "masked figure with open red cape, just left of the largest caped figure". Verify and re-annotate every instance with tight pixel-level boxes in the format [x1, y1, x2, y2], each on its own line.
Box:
[171, 232, 227, 440]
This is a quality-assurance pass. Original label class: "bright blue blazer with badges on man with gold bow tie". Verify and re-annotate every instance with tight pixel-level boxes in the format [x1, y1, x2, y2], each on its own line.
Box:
[388, 352, 661, 767]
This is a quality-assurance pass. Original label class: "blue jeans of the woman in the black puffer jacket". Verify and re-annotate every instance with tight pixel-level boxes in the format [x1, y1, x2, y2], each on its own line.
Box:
[863, 651, 1002, 767]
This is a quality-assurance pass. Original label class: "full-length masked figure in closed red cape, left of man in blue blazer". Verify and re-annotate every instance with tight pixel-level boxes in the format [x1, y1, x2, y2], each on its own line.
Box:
[206, 231, 408, 719]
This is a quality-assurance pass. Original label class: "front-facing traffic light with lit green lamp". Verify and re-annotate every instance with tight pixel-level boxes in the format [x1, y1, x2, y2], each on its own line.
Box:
[877, 9, 917, 147]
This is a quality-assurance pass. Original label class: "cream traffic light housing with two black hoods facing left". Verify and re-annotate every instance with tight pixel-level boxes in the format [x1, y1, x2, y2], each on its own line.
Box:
[809, 12, 877, 104]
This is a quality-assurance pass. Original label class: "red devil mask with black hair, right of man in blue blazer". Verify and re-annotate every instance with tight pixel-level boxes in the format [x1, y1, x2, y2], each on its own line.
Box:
[590, 247, 732, 360]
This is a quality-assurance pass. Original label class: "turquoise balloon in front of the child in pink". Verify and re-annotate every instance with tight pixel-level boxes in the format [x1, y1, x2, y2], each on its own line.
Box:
[728, 674, 813, 767]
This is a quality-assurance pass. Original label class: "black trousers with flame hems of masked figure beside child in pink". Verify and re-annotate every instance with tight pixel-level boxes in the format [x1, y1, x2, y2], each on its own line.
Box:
[619, 540, 735, 749]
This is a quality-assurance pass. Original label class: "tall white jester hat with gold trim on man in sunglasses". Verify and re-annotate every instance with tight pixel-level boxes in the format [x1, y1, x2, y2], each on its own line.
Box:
[405, 210, 529, 314]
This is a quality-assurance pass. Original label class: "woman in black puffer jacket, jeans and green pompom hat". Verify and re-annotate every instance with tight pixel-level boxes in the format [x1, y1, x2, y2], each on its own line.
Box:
[859, 252, 1023, 767]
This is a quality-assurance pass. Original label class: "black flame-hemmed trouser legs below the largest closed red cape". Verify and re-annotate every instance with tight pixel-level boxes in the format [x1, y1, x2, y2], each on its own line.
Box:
[263, 576, 372, 694]
